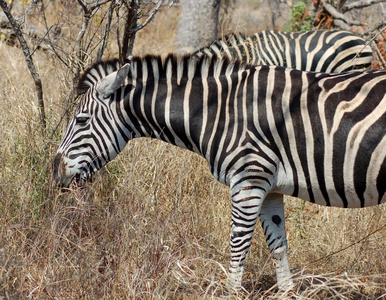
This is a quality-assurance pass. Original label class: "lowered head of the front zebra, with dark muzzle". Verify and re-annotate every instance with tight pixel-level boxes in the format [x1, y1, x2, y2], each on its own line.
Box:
[53, 61, 130, 187]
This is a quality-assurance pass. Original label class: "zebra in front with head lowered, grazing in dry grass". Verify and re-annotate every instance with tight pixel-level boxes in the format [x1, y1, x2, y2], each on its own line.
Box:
[53, 55, 386, 289]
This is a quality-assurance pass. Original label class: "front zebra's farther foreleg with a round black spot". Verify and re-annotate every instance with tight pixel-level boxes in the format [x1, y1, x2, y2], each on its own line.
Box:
[259, 194, 294, 290]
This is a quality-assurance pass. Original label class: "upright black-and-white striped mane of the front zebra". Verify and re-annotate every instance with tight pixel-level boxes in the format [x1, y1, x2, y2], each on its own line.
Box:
[76, 54, 252, 96]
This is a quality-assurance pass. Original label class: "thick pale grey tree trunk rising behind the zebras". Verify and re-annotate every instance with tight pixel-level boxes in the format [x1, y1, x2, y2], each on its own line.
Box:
[174, 0, 220, 54]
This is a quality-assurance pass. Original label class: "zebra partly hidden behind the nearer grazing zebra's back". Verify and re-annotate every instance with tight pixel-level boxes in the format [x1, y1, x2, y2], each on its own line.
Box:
[194, 30, 373, 73]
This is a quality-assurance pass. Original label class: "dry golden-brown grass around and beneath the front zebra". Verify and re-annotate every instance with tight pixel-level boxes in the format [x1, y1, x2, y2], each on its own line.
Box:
[0, 1, 386, 299]
